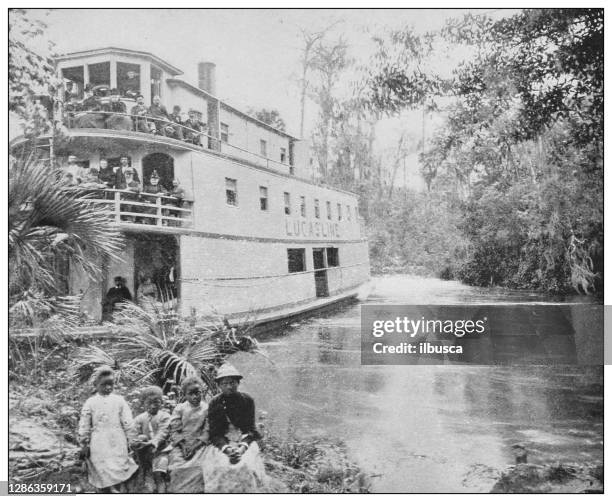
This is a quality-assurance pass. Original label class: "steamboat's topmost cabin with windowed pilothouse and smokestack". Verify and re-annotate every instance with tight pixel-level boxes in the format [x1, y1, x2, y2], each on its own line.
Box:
[57, 47, 308, 177]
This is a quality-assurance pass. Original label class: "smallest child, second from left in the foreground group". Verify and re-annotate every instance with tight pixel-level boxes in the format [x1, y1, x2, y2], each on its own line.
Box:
[132, 385, 170, 493]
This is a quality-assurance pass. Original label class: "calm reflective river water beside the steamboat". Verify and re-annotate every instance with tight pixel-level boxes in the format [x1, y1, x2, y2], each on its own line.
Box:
[231, 276, 603, 492]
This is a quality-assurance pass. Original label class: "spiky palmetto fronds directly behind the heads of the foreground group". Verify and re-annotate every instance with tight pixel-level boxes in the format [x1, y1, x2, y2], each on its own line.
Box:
[73, 301, 260, 395]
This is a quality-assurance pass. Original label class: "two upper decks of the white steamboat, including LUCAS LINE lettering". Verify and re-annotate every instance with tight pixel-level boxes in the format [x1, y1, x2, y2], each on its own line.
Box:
[13, 48, 364, 242]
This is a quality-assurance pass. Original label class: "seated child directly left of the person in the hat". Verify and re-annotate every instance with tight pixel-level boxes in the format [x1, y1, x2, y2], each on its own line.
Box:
[168, 377, 208, 493]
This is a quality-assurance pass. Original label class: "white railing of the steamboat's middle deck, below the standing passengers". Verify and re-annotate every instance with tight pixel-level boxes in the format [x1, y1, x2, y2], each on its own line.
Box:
[86, 188, 193, 228]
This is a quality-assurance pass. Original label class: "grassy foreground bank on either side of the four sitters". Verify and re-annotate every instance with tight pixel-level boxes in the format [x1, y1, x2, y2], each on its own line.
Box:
[9, 344, 368, 493]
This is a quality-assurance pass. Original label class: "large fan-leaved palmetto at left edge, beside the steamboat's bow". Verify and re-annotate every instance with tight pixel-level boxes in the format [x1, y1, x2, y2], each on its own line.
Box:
[8, 155, 123, 327]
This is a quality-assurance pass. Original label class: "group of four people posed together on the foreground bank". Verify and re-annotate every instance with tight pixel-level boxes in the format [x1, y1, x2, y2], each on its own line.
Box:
[79, 364, 265, 493]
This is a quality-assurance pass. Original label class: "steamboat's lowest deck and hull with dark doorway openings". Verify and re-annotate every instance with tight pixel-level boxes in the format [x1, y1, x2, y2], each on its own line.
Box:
[69, 229, 369, 322]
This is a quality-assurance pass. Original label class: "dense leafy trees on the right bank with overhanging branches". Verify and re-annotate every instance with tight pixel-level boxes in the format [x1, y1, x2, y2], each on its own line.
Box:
[354, 9, 603, 293]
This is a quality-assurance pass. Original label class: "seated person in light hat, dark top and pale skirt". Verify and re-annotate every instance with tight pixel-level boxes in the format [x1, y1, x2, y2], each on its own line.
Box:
[203, 364, 269, 493]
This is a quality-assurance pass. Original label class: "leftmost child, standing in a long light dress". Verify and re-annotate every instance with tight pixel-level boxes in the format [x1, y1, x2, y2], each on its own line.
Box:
[79, 366, 138, 493]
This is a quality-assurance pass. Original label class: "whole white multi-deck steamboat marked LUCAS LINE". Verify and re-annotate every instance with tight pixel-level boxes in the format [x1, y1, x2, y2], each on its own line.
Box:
[12, 47, 369, 323]
